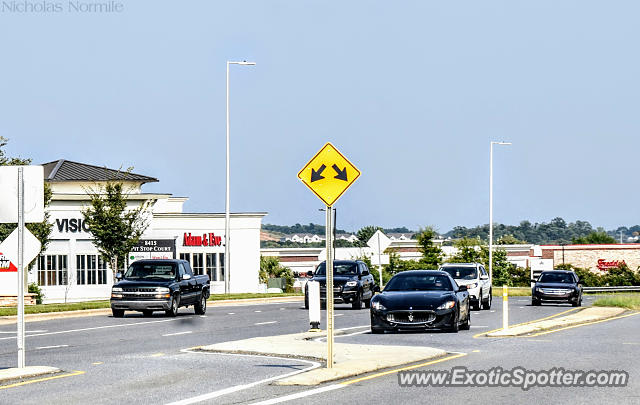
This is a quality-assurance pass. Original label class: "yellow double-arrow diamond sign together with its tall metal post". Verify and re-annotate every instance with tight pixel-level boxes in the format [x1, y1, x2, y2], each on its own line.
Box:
[298, 142, 360, 368]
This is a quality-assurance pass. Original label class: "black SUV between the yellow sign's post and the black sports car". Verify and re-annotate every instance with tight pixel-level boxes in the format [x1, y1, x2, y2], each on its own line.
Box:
[304, 260, 378, 309]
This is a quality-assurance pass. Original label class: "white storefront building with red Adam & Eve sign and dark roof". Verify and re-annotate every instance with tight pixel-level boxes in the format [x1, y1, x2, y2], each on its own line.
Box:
[29, 160, 266, 302]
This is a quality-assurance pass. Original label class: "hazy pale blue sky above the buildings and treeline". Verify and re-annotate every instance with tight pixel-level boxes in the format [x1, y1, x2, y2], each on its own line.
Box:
[0, 0, 640, 232]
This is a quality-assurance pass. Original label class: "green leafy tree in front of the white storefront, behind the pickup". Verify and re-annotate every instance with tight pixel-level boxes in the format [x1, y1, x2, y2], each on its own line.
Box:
[82, 181, 149, 280]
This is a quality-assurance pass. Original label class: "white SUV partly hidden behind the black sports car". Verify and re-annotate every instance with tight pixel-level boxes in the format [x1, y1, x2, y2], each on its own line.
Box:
[439, 263, 492, 310]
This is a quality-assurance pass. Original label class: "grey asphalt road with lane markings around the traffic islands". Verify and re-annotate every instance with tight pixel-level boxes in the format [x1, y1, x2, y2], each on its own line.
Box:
[0, 297, 640, 404]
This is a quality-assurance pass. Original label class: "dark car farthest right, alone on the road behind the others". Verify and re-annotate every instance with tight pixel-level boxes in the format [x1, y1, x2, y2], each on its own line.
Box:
[531, 270, 582, 307]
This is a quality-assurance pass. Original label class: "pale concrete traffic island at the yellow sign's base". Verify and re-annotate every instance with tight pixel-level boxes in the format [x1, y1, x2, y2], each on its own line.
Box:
[197, 331, 447, 385]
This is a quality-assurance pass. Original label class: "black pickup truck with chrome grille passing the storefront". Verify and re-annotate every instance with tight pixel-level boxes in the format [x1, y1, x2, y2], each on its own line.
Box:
[111, 259, 210, 318]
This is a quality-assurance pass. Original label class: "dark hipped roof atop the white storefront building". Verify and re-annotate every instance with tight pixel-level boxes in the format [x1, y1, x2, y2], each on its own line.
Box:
[42, 159, 158, 184]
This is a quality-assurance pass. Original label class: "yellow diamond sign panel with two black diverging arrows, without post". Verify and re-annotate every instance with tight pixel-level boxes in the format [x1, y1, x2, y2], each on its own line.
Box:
[298, 142, 360, 206]
